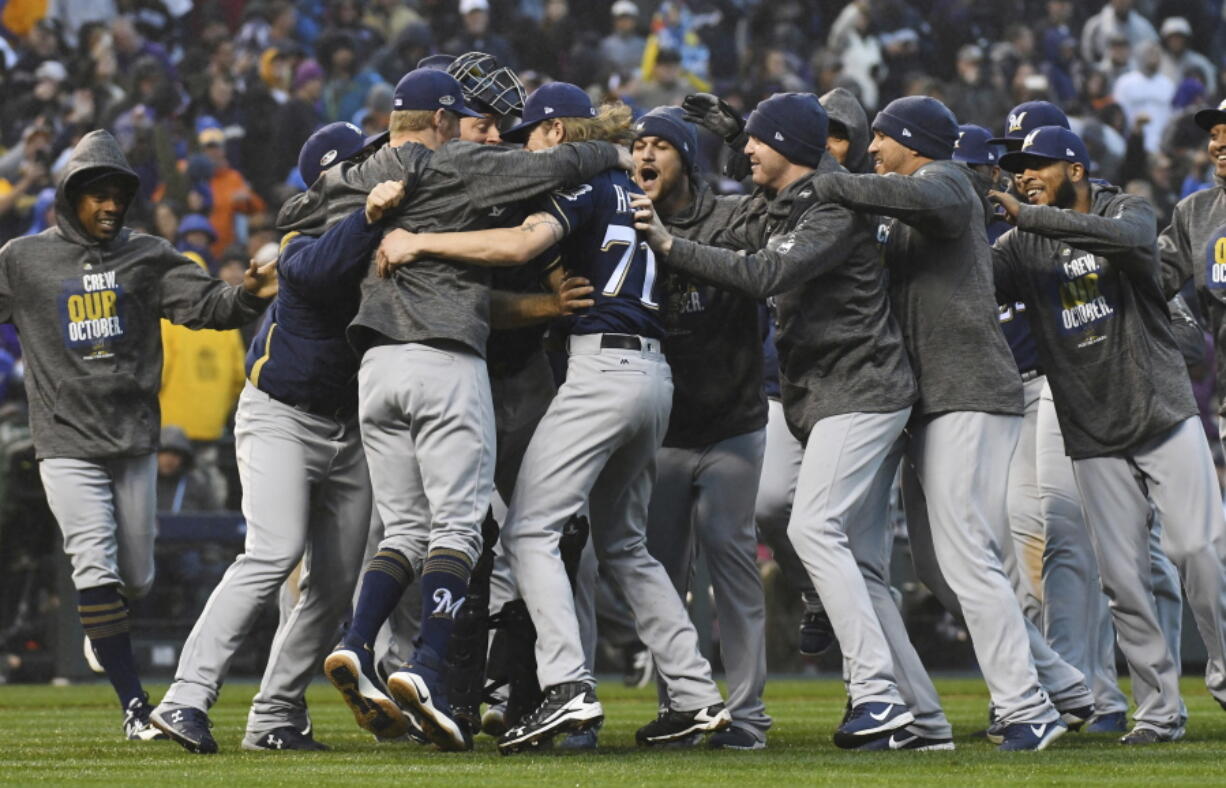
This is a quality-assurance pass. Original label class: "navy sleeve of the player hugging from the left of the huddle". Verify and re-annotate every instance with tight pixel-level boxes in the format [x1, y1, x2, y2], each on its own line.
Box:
[277, 211, 384, 295]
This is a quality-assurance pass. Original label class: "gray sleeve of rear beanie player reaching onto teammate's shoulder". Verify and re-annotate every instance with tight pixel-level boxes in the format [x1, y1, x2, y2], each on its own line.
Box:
[814, 170, 973, 238]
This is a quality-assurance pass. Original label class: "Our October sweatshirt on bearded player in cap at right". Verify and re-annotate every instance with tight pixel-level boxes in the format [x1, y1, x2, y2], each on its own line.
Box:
[992, 184, 1197, 460]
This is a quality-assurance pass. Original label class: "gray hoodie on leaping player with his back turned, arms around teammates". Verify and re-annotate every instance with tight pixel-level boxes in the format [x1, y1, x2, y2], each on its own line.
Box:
[277, 140, 618, 357]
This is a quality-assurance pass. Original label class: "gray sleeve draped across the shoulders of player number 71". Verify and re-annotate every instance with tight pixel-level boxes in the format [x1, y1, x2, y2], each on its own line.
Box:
[449, 142, 618, 208]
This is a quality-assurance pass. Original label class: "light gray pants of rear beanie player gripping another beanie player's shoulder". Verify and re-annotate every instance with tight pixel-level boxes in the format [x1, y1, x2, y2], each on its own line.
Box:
[904, 411, 1063, 724]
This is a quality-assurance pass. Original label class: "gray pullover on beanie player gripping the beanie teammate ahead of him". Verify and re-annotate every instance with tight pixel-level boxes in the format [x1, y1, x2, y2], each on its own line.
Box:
[814, 161, 1022, 417]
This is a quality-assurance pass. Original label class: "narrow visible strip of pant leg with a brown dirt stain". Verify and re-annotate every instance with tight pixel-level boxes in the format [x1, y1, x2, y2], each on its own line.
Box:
[1002, 375, 1047, 627]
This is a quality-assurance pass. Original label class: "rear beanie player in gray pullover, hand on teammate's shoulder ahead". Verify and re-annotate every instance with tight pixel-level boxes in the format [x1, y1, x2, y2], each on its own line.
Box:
[813, 97, 1068, 750]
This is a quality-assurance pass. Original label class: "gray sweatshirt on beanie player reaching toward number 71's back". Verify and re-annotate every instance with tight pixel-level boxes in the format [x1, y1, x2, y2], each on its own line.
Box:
[666, 154, 917, 441]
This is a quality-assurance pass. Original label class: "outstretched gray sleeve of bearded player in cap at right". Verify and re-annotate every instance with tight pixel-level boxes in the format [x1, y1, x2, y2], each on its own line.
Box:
[1018, 195, 1157, 276]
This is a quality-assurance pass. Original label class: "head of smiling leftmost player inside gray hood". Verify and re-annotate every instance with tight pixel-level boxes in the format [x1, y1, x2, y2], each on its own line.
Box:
[55, 130, 141, 245]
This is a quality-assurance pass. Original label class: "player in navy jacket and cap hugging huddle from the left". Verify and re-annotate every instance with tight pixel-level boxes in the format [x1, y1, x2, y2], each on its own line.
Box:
[151, 123, 405, 754]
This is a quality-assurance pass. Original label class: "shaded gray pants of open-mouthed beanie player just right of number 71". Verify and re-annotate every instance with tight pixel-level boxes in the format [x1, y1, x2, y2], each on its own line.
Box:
[647, 429, 771, 739]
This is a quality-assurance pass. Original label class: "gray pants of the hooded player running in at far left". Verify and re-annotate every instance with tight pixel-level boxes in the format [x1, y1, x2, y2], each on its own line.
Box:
[38, 452, 157, 599]
